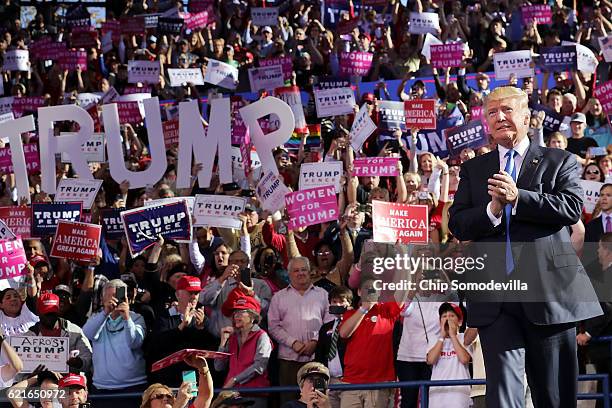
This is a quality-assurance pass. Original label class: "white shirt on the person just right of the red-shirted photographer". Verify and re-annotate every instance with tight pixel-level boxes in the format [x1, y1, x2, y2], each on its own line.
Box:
[397, 298, 442, 362]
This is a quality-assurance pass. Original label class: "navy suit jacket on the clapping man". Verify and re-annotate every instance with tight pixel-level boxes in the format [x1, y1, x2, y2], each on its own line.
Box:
[449, 144, 601, 327]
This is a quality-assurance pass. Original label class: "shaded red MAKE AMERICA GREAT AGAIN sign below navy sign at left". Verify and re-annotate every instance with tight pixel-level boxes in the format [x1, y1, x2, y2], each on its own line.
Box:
[51, 220, 102, 262]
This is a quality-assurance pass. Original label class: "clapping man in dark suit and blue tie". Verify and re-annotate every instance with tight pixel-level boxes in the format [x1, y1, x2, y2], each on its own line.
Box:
[449, 87, 601, 408]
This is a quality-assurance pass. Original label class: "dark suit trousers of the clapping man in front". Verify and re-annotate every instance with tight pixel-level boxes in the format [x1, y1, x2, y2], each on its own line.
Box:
[479, 303, 578, 408]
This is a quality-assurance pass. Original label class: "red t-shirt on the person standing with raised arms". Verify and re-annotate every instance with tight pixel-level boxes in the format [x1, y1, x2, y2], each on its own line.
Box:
[342, 302, 401, 384]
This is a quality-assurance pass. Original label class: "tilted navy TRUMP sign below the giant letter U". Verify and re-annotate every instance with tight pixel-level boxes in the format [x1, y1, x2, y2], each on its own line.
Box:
[121, 201, 192, 256]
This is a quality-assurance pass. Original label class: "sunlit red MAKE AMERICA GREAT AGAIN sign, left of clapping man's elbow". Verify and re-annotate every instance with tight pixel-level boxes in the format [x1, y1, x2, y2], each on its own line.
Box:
[372, 201, 429, 244]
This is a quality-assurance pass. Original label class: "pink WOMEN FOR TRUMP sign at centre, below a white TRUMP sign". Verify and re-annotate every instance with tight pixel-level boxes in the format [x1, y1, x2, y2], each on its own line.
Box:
[285, 186, 338, 230]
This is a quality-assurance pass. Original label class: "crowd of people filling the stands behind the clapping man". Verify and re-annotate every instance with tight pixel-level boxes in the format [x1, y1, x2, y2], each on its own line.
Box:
[0, 0, 612, 408]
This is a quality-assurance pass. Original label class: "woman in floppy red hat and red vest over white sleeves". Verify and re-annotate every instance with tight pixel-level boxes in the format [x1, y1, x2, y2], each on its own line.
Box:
[215, 288, 272, 408]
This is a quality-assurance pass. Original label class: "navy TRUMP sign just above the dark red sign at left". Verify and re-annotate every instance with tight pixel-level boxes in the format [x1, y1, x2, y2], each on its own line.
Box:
[32, 202, 83, 238]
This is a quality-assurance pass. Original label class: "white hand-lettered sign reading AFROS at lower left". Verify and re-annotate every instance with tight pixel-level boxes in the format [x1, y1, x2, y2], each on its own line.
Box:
[7, 336, 70, 373]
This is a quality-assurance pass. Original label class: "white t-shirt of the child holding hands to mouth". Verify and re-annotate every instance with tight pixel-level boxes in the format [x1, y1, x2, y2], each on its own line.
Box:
[429, 333, 472, 408]
